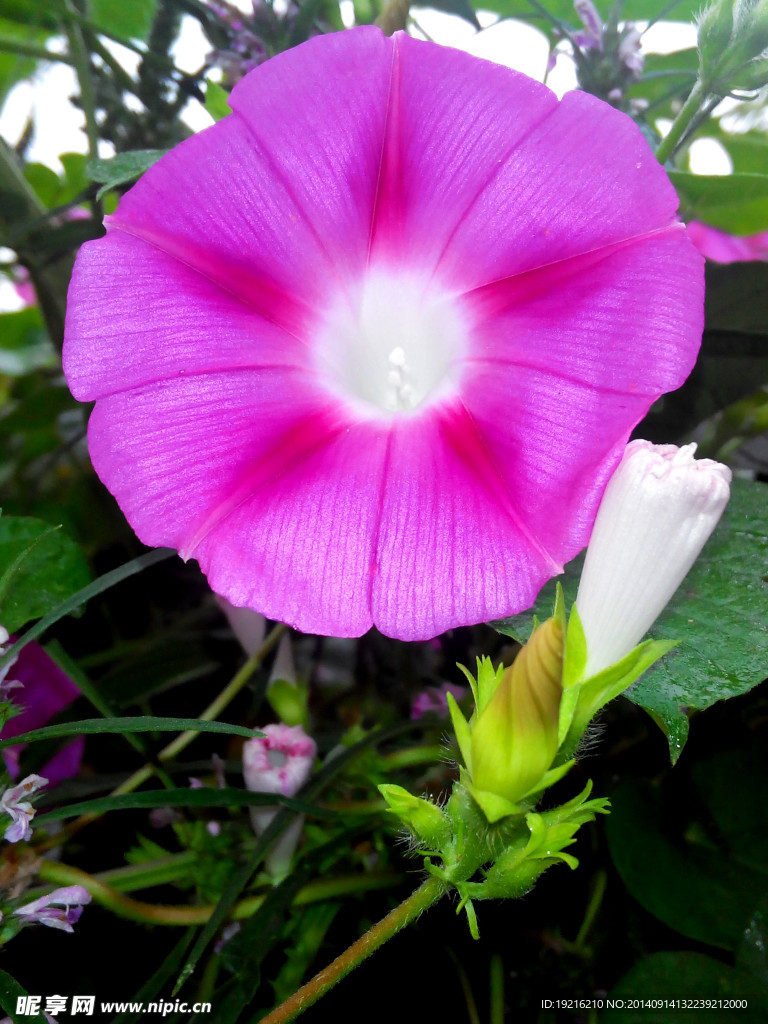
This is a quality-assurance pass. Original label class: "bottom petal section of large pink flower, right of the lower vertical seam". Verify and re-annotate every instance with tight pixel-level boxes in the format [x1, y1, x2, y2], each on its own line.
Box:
[373, 403, 561, 640]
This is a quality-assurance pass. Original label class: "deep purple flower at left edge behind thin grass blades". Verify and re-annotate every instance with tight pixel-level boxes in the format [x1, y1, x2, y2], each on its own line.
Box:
[0, 630, 85, 785]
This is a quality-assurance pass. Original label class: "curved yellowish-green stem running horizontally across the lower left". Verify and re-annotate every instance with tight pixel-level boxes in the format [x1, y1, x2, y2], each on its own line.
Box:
[38, 860, 408, 929]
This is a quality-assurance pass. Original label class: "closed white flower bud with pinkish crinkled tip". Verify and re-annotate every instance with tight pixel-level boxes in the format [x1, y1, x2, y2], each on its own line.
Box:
[575, 440, 731, 678]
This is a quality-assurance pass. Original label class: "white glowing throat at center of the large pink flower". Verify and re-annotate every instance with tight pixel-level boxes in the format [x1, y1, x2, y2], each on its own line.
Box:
[315, 271, 468, 413]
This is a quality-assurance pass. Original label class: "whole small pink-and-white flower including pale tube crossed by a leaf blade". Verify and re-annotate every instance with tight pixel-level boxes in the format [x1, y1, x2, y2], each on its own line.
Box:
[243, 723, 317, 880]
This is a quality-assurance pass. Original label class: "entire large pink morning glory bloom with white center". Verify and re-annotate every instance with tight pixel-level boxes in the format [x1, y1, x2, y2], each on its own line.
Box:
[65, 28, 702, 639]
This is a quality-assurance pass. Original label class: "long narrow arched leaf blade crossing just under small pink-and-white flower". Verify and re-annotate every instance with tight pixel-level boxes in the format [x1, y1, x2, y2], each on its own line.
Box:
[35, 786, 338, 825]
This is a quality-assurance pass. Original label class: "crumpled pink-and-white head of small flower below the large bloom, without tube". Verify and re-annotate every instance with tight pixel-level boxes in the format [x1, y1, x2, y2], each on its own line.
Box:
[243, 724, 317, 797]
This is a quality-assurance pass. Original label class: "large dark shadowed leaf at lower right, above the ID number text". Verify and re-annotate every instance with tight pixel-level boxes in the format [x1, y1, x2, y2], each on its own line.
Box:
[605, 782, 768, 949]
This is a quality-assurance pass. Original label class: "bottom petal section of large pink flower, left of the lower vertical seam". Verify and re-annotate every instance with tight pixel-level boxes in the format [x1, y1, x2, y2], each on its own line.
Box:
[195, 420, 388, 636]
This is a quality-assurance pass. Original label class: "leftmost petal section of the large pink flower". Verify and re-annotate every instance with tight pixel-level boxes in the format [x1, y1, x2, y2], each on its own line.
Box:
[65, 230, 307, 401]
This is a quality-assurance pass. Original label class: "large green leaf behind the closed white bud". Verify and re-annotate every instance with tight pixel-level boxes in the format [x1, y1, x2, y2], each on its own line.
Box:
[492, 479, 768, 762]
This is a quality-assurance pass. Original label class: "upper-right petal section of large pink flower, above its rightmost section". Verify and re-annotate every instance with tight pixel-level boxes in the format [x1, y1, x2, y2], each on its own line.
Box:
[440, 86, 684, 292]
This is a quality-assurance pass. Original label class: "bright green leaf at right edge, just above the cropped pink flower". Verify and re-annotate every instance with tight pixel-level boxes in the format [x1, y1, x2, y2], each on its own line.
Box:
[670, 171, 768, 234]
